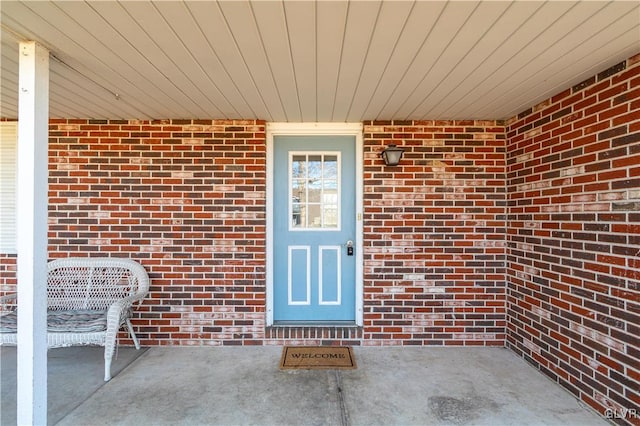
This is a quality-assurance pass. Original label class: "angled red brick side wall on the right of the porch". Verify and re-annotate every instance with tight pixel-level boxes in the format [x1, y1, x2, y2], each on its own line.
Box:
[507, 55, 640, 423]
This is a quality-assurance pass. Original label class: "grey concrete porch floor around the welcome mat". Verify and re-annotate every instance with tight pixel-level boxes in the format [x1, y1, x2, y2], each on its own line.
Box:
[0, 346, 608, 426]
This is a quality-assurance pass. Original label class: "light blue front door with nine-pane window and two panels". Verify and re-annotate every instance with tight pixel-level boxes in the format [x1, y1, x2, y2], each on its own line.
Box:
[273, 136, 358, 323]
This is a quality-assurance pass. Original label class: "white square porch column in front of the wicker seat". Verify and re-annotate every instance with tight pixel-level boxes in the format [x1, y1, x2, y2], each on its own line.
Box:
[17, 42, 49, 425]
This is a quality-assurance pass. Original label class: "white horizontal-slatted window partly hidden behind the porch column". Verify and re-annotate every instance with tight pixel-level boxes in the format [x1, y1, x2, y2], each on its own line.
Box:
[0, 121, 18, 253]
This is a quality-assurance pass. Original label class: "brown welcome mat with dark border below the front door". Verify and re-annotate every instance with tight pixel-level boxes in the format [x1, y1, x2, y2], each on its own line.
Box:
[280, 346, 357, 370]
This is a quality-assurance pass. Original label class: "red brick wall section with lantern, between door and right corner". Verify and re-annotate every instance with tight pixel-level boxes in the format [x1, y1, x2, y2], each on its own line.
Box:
[364, 120, 506, 346]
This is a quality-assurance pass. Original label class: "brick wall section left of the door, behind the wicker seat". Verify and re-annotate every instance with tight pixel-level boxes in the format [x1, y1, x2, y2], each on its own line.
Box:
[49, 120, 266, 345]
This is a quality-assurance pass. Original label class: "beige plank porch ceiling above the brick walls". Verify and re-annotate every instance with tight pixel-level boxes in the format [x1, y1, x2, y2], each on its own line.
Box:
[0, 0, 640, 122]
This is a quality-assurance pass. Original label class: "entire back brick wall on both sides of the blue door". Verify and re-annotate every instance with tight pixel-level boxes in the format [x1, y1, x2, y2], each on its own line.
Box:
[0, 116, 506, 345]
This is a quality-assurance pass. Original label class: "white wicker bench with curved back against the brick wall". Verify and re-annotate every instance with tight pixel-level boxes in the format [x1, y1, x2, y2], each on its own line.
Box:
[0, 258, 149, 381]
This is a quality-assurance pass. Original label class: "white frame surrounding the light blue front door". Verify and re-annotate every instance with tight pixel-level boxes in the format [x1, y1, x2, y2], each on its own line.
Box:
[266, 123, 364, 326]
